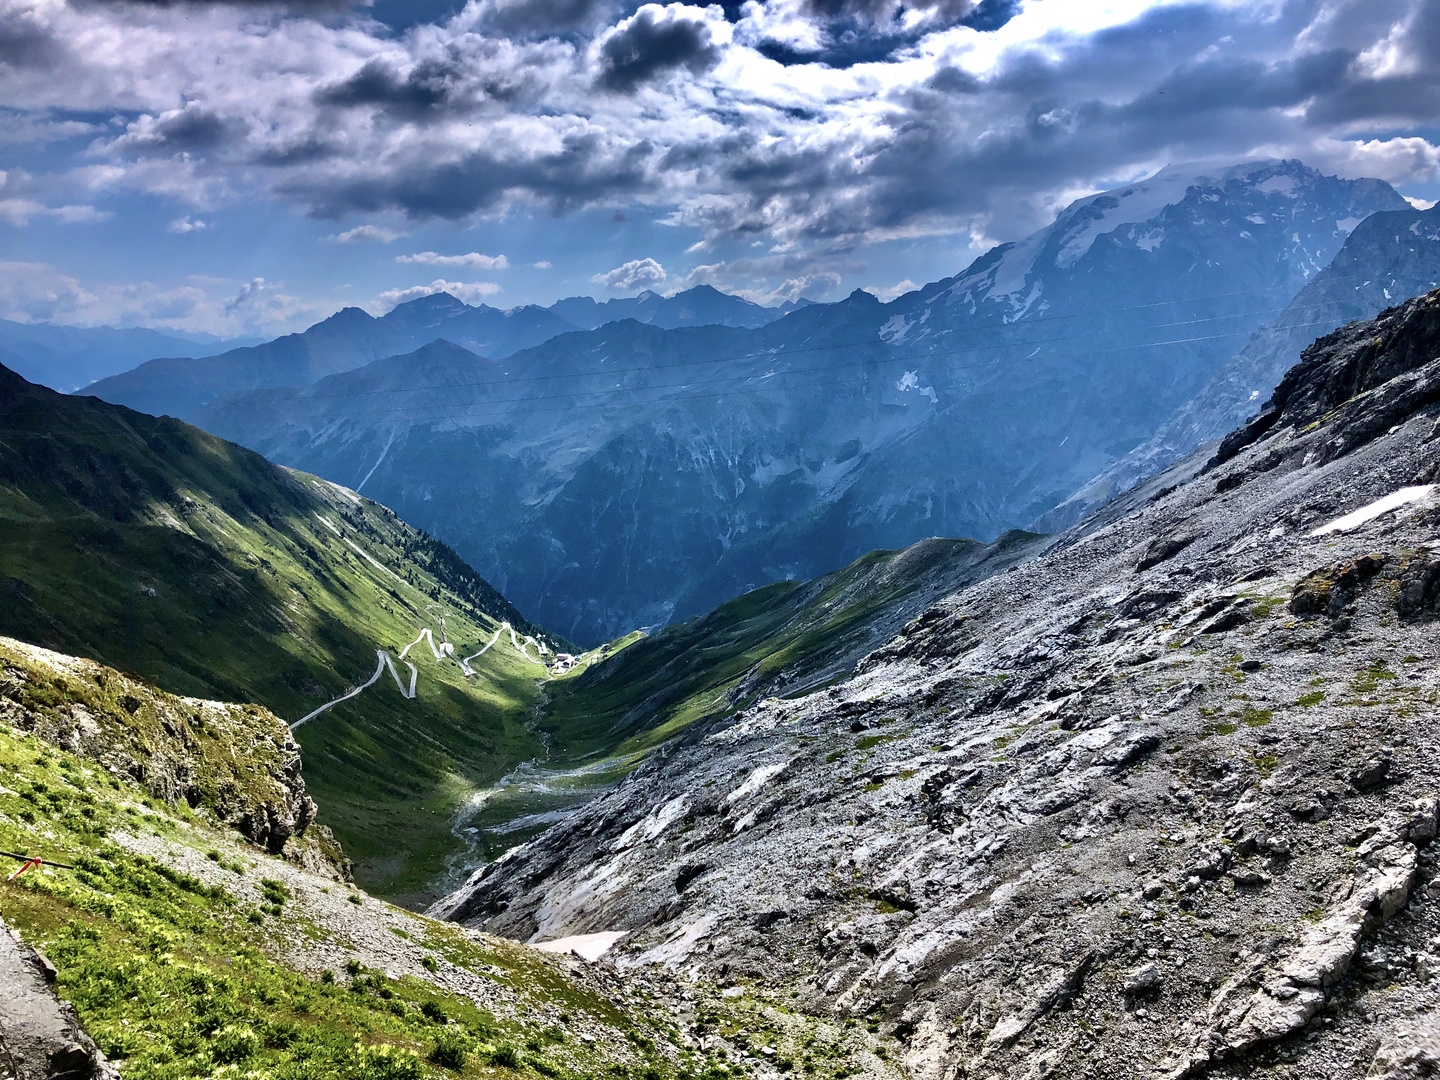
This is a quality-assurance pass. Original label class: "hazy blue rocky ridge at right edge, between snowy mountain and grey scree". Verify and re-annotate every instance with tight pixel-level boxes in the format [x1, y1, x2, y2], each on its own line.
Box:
[1037, 207, 1440, 531]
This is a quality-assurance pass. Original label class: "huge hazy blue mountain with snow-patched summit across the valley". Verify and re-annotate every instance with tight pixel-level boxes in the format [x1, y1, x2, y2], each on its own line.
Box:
[194, 161, 1407, 645]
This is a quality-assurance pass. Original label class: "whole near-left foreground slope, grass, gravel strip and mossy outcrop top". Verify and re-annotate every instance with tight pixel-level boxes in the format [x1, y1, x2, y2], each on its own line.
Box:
[0, 641, 901, 1080]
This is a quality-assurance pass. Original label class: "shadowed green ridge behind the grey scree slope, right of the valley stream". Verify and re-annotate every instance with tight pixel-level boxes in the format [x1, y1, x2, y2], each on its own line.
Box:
[445, 533, 1044, 888]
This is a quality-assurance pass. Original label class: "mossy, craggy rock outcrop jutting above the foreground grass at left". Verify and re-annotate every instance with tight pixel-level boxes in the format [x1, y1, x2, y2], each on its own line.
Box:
[0, 638, 348, 878]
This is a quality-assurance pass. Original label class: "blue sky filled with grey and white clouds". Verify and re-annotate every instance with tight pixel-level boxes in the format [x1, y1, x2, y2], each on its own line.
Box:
[0, 0, 1440, 337]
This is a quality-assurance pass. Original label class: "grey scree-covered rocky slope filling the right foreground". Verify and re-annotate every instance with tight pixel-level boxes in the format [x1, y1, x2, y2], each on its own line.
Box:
[436, 292, 1440, 1080]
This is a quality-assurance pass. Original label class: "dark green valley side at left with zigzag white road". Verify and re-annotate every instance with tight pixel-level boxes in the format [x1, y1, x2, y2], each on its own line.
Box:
[0, 369, 560, 901]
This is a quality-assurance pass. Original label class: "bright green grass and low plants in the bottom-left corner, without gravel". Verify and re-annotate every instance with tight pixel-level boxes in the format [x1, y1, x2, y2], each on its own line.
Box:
[0, 724, 714, 1080]
